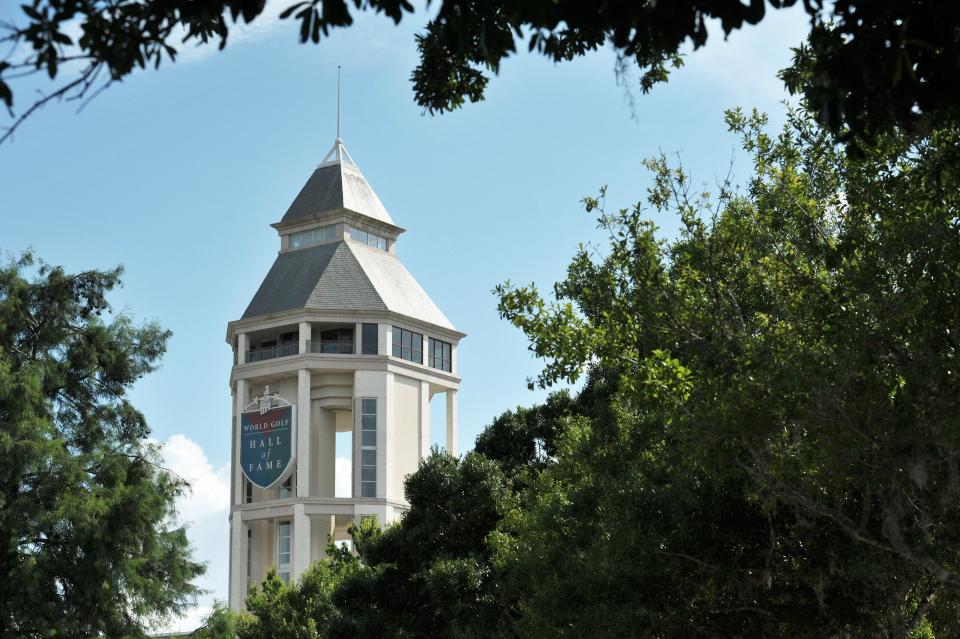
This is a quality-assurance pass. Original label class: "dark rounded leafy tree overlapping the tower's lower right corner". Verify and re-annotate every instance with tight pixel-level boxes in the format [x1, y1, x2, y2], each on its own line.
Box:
[330, 450, 510, 637]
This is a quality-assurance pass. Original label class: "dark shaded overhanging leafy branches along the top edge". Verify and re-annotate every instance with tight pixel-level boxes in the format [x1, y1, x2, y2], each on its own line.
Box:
[0, 0, 960, 142]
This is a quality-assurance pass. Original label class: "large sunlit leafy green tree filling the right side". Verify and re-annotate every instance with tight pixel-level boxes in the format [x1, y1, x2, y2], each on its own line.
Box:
[495, 111, 960, 637]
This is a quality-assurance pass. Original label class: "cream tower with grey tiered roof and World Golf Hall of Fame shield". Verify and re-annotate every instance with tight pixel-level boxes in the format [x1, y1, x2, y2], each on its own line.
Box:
[227, 137, 465, 609]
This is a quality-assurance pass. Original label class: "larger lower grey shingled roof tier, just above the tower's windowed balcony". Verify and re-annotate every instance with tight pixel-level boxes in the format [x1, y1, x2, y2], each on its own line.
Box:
[242, 240, 456, 330]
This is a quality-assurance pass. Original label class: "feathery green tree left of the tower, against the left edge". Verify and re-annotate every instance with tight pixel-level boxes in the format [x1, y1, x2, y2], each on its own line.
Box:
[0, 254, 203, 638]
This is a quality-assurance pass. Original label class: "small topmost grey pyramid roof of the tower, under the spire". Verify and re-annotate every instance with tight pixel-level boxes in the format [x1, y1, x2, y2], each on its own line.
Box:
[277, 138, 396, 226]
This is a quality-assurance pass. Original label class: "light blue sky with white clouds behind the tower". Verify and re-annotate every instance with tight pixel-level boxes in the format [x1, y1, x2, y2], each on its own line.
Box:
[0, 2, 806, 628]
